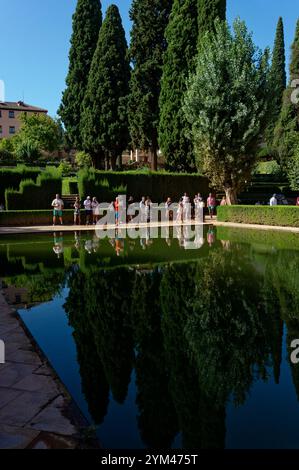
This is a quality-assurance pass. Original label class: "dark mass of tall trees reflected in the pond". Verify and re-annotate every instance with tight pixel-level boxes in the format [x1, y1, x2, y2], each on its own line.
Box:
[65, 245, 284, 448]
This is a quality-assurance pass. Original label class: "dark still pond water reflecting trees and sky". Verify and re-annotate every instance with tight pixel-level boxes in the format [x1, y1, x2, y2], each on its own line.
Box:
[0, 228, 299, 449]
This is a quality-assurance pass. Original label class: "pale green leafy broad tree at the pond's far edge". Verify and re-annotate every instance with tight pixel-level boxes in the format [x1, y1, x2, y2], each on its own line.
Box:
[184, 20, 269, 203]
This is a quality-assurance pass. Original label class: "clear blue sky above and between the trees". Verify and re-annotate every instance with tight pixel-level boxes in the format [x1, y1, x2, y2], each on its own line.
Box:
[0, 0, 299, 116]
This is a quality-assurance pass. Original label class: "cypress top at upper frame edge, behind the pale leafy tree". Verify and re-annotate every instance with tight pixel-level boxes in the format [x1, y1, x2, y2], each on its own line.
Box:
[198, 0, 226, 41]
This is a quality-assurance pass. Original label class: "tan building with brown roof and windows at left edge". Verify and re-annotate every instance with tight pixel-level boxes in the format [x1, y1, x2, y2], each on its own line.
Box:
[0, 101, 48, 139]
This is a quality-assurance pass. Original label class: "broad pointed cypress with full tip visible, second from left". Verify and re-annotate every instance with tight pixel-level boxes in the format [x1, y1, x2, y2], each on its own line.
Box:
[81, 5, 130, 169]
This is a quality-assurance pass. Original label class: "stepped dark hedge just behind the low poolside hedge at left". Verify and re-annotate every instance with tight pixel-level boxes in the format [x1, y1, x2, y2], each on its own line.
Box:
[5, 170, 62, 210]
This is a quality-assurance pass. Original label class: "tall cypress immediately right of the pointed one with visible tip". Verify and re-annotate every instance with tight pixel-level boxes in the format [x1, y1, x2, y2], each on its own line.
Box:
[128, 0, 173, 170]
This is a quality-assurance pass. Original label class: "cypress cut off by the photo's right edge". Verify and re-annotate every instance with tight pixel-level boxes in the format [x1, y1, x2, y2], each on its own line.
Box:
[273, 19, 299, 169]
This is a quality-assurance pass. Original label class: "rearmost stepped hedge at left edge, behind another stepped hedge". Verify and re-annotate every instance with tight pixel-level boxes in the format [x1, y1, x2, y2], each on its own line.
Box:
[0, 166, 41, 203]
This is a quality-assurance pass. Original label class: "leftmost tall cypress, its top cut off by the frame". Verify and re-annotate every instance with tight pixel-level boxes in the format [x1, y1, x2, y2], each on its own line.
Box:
[58, 0, 102, 148]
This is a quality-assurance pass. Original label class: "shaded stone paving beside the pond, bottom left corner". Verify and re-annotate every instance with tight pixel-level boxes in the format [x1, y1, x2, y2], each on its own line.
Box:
[0, 291, 86, 449]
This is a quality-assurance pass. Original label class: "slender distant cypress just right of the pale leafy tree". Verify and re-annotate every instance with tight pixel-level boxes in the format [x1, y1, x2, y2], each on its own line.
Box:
[266, 17, 287, 148]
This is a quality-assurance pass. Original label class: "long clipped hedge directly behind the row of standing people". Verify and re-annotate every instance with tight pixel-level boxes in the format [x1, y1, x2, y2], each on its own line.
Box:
[78, 169, 209, 202]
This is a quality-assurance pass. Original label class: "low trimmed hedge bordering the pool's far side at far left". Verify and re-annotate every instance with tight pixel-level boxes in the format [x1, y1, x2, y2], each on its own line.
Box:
[0, 210, 74, 226]
